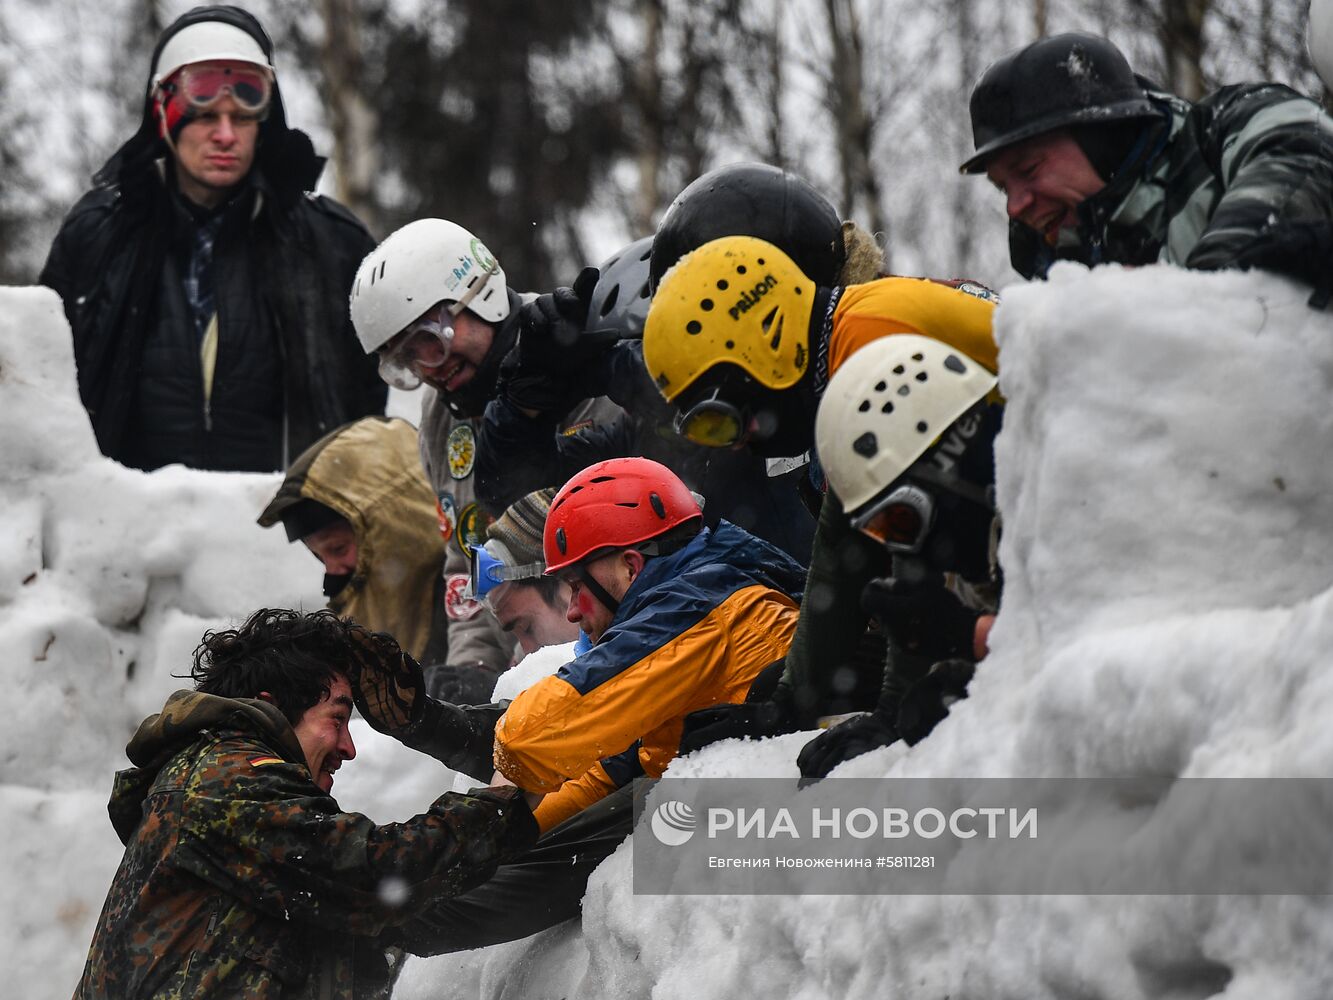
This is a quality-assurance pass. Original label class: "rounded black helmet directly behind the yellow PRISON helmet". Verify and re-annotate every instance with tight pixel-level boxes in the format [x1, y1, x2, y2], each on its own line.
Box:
[649, 163, 846, 289]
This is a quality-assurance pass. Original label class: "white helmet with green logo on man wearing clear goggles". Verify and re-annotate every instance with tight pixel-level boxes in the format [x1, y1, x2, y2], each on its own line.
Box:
[351, 219, 509, 355]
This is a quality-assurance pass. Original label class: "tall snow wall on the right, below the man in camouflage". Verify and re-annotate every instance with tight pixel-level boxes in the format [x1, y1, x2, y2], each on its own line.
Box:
[567, 265, 1333, 1000]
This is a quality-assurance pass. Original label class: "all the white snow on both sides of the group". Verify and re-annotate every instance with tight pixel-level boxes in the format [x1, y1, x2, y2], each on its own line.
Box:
[0, 265, 1333, 1000]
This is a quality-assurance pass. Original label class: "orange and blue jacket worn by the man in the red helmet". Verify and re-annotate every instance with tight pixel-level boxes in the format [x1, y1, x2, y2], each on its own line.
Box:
[495, 521, 805, 831]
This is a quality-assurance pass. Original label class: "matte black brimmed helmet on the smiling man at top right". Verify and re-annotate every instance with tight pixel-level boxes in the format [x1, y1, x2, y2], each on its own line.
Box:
[958, 32, 1156, 173]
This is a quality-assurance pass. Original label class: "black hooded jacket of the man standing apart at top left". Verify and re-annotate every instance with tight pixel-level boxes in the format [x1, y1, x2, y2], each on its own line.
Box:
[41, 7, 387, 471]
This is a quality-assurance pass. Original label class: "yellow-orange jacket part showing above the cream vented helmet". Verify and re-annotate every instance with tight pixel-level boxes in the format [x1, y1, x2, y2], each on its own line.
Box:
[829, 277, 1000, 377]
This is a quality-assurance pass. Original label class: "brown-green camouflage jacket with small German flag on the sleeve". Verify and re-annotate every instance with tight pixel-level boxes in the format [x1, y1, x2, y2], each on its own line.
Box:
[75, 691, 537, 1000]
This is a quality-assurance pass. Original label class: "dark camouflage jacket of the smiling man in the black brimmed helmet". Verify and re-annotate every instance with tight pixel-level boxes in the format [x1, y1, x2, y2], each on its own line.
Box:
[1009, 84, 1333, 277]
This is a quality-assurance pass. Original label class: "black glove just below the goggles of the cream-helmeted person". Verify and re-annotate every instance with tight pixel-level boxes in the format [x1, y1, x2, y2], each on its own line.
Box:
[861, 573, 981, 660]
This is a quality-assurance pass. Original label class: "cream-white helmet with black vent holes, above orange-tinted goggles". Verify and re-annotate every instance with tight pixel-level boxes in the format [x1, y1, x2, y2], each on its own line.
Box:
[814, 333, 997, 519]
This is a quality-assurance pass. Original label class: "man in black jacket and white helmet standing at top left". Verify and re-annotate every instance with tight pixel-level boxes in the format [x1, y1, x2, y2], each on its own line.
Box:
[41, 7, 387, 472]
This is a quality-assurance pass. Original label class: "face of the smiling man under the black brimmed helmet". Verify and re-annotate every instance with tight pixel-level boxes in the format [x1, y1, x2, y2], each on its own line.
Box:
[986, 129, 1106, 245]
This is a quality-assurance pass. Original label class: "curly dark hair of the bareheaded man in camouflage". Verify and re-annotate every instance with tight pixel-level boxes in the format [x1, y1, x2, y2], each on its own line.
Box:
[189, 608, 368, 725]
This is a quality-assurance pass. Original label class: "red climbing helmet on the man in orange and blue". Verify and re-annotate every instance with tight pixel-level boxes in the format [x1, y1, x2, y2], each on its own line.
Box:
[541, 459, 704, 576]
